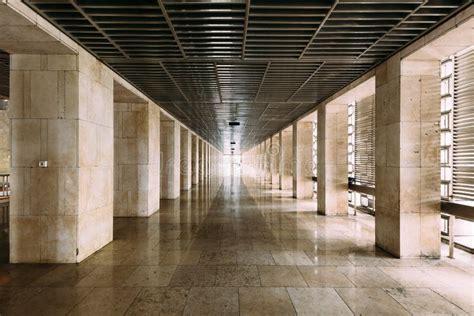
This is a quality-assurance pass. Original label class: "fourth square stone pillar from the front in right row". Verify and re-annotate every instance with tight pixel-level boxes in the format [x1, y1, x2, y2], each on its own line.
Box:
[279, 128, 293, 190]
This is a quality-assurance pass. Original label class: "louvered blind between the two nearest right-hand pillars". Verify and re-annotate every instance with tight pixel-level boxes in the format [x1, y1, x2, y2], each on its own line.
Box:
[354, 95, 375, 187]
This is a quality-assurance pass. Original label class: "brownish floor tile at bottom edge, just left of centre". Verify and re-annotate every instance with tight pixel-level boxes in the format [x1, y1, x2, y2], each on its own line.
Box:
[184, 287, 239, 315]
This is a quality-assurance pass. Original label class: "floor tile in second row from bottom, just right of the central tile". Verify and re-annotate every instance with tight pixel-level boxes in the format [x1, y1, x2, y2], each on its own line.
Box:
[258, 266, 308, 287]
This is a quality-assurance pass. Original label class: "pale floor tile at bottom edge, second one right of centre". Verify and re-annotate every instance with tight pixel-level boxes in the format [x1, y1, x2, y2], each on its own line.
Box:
[288, 288, 353, 316]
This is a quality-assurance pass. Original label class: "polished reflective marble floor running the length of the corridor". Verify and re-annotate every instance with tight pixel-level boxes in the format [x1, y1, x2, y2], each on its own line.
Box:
[0, 178, 474, 315]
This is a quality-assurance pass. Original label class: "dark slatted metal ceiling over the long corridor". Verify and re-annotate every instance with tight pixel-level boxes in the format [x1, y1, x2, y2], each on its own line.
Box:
[25, 0, 471, 152]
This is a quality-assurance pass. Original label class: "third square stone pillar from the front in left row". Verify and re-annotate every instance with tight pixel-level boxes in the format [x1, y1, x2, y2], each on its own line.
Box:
[160, 115, 181, 200]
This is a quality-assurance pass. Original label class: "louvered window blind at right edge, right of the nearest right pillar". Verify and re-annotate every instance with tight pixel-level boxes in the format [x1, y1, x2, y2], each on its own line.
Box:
[453, 49, 474, 200]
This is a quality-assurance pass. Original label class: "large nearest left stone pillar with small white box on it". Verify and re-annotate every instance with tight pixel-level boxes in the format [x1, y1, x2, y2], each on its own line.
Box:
[9, 52, 114, 263]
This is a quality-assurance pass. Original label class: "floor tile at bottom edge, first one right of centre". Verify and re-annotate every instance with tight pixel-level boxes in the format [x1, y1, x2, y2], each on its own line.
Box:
[239, 287, 296, 316]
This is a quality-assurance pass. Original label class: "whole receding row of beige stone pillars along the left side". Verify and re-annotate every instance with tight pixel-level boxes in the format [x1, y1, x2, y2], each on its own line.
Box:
[9, 52, 222, 263]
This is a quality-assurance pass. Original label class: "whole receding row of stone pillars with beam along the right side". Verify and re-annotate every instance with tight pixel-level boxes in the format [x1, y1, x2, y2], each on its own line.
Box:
[244, 8, 474, 257]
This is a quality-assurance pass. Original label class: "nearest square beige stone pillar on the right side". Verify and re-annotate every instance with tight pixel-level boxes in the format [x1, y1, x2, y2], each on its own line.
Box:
[375, 54, 440, 257]
